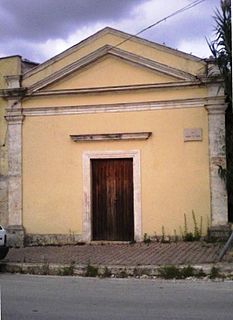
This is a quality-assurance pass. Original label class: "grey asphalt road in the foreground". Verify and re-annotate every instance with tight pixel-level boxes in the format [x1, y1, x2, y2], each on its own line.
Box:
[0, 274, 233, 320]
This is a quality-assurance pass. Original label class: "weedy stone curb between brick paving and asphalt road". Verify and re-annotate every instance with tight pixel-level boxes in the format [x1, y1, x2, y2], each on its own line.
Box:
[0, 260, 233, 279]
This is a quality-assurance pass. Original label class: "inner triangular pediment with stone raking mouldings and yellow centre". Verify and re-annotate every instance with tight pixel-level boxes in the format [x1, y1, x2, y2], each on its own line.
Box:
[25, 45, 195, 92]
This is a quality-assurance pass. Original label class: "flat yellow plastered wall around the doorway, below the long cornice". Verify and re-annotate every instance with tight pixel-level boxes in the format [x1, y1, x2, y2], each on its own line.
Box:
[23, 108, 210, 235]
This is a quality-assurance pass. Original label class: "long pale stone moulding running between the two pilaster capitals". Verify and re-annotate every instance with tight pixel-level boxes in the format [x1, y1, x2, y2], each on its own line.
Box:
[23, 98, 210, 116]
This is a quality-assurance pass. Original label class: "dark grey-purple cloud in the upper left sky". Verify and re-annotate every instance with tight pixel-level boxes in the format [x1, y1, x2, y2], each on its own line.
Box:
[0, 0, 145, 41]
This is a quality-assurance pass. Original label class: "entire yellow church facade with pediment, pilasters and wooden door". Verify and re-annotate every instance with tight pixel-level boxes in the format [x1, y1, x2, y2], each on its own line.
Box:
[1, 28, 228, 245]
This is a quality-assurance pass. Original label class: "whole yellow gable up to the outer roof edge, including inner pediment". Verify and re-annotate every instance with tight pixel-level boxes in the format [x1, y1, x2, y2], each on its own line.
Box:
[22, 27, 205, 94]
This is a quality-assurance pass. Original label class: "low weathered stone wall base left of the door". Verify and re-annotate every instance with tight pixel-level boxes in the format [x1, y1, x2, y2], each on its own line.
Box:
[24, 233, 83, 246]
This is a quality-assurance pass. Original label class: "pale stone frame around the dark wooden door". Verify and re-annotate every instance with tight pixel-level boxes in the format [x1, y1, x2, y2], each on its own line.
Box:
[82, 150, 142, 242]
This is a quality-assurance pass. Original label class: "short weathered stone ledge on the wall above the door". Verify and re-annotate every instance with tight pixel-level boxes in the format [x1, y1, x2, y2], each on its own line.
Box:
[70, 132, 152, 142]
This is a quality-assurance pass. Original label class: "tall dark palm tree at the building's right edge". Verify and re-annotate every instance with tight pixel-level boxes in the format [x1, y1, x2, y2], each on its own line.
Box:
[209, 0, 233, 222]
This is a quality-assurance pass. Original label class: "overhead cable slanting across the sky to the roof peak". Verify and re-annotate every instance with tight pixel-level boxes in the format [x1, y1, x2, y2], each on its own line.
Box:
[112, 0, 206, 48]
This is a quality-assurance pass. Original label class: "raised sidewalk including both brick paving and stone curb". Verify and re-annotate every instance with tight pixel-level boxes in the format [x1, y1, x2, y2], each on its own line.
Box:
[0, 241, 233, 278]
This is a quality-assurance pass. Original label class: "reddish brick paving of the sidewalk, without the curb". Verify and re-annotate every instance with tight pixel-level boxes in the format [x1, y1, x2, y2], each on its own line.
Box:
[7, 242, 233, 266]
